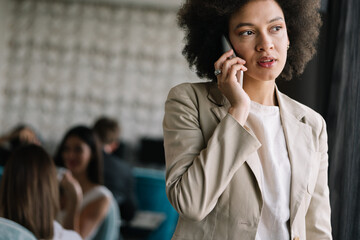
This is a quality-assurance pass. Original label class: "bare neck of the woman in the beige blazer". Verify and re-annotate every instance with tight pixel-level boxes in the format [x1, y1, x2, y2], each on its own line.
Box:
[244, 80, 278, 106]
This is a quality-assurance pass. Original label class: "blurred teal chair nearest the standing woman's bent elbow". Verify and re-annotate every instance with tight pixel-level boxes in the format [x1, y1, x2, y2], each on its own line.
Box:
[133, 168, 178, 240]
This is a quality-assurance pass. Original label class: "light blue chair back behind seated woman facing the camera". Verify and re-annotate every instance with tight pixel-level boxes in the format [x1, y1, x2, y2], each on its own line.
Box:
[92, 193, 122, 240]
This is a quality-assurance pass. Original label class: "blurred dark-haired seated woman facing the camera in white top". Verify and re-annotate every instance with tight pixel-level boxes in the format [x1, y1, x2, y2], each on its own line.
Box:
[55, 126, 118, 239]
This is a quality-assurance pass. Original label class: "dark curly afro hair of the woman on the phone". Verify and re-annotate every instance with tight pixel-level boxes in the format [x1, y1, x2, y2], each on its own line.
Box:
[178, 0, 322, 82]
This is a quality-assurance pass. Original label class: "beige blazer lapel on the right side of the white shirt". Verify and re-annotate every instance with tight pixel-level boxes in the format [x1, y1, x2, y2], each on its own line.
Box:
[276, 89, 314, 226]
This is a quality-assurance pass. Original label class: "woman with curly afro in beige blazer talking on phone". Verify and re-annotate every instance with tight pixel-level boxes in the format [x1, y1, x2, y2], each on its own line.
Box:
[163, 0, 331, 240]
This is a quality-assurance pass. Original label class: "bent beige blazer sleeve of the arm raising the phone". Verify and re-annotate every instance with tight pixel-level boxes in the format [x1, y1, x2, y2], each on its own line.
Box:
[163, 85, 260, 221]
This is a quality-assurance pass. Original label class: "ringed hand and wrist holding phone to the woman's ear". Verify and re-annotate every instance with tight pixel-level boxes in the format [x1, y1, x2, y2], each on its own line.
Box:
[214, 49, 250, 126]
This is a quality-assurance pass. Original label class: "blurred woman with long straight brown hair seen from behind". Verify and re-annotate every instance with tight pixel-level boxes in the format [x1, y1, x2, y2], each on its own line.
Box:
[0, 145, 81, 240]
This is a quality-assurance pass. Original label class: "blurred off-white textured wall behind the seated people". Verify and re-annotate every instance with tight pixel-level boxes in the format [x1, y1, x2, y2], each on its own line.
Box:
[0, 0, 197, 151]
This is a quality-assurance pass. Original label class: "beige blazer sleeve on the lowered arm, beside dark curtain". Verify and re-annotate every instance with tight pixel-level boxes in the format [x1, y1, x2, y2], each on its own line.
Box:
[306, 118, 332, 240]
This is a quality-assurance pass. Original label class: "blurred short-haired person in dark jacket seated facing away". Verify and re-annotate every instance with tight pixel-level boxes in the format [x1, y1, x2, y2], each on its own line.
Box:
[93, 116, 137, 221]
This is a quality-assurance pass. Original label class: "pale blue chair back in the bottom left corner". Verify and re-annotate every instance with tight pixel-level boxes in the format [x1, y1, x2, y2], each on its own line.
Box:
[0, 217, 36, 240]
